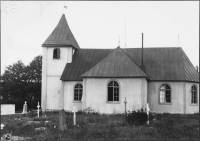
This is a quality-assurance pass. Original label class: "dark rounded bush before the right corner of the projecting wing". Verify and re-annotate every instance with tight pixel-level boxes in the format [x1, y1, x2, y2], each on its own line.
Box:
[125, 108, 148, 125]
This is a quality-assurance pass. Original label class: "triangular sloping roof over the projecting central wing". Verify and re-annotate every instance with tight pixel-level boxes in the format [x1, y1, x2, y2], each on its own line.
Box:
[81, 47, 147, 78]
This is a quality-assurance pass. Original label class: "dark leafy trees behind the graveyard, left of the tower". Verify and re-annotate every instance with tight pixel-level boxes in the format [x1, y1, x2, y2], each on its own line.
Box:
[0, 55, 42, 109]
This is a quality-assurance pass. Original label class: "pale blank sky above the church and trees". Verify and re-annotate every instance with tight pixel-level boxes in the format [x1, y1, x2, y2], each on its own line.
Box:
[1, 1, 199, 74]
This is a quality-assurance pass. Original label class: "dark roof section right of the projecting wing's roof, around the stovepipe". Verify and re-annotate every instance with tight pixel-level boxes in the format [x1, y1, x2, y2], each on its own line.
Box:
[124, 47, 199, 82]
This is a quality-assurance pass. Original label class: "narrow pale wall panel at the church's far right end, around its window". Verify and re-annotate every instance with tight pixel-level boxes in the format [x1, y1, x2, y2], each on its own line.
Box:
[185, 82, 199, 113]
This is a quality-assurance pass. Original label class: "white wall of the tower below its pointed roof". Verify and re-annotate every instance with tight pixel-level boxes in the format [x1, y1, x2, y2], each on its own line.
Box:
[41, 47, 73, 110]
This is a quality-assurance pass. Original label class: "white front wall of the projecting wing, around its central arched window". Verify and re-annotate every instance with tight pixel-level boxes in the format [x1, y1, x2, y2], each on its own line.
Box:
[83, 78, 147, 113]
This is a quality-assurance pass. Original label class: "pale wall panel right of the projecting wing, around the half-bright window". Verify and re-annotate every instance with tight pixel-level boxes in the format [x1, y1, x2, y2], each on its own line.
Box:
[147, 82, 184, 113]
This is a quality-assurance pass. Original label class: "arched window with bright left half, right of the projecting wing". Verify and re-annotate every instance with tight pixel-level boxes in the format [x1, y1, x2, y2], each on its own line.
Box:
[160, 84, 171, 103]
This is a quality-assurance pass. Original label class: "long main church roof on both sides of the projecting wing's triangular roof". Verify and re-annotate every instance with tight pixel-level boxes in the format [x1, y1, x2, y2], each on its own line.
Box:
[61, 47, 199, 82]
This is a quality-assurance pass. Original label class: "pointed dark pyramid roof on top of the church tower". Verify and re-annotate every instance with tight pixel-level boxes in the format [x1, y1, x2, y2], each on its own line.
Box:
[42, 14, 80, 49]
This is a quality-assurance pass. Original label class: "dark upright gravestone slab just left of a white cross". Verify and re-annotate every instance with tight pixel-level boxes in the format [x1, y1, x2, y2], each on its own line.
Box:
[58, 109, 67, 131]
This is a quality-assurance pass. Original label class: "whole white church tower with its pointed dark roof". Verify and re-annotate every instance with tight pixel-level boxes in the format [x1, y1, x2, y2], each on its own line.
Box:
[41, 14, 80, 111]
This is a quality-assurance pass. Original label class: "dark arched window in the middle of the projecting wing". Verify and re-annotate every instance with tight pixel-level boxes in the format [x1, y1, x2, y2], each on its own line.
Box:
[108, 81, 119, 101]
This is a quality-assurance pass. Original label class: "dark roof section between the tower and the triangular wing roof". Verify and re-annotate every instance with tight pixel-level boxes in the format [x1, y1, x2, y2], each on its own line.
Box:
[61, 49, 113, 81]
